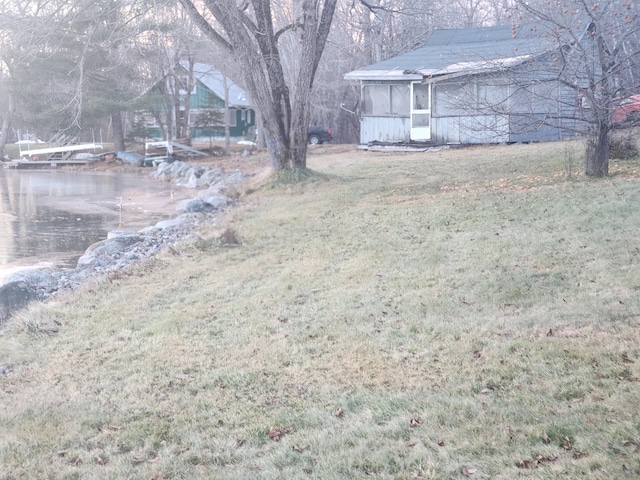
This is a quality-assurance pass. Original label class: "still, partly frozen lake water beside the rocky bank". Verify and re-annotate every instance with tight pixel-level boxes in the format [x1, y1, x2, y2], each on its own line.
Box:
[0, 168, 193, 283]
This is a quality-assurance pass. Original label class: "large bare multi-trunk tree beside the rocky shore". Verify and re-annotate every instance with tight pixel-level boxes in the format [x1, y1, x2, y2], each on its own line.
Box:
[174, 0, 337, 171]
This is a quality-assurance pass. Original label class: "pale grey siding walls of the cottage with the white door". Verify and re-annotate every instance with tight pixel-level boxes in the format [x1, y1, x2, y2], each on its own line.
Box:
[360, 69, 575, 145]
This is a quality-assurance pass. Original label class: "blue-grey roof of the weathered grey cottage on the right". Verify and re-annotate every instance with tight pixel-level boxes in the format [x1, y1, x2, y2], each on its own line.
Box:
[344, 24, 554, 80]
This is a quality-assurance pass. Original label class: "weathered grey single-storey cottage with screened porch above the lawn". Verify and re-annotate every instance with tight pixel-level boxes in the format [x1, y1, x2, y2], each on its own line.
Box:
[345, 24, 593, 144]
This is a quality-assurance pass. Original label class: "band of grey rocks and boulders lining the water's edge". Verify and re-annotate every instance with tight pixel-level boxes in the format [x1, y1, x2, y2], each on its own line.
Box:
[0, 161, 244, 325]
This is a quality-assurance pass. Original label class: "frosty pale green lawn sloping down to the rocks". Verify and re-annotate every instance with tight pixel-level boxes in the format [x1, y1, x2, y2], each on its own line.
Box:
[0, 138, 640, 480]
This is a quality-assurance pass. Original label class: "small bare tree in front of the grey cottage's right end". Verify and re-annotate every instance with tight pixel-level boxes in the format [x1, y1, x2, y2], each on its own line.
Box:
[515, 0, 640, 176]
